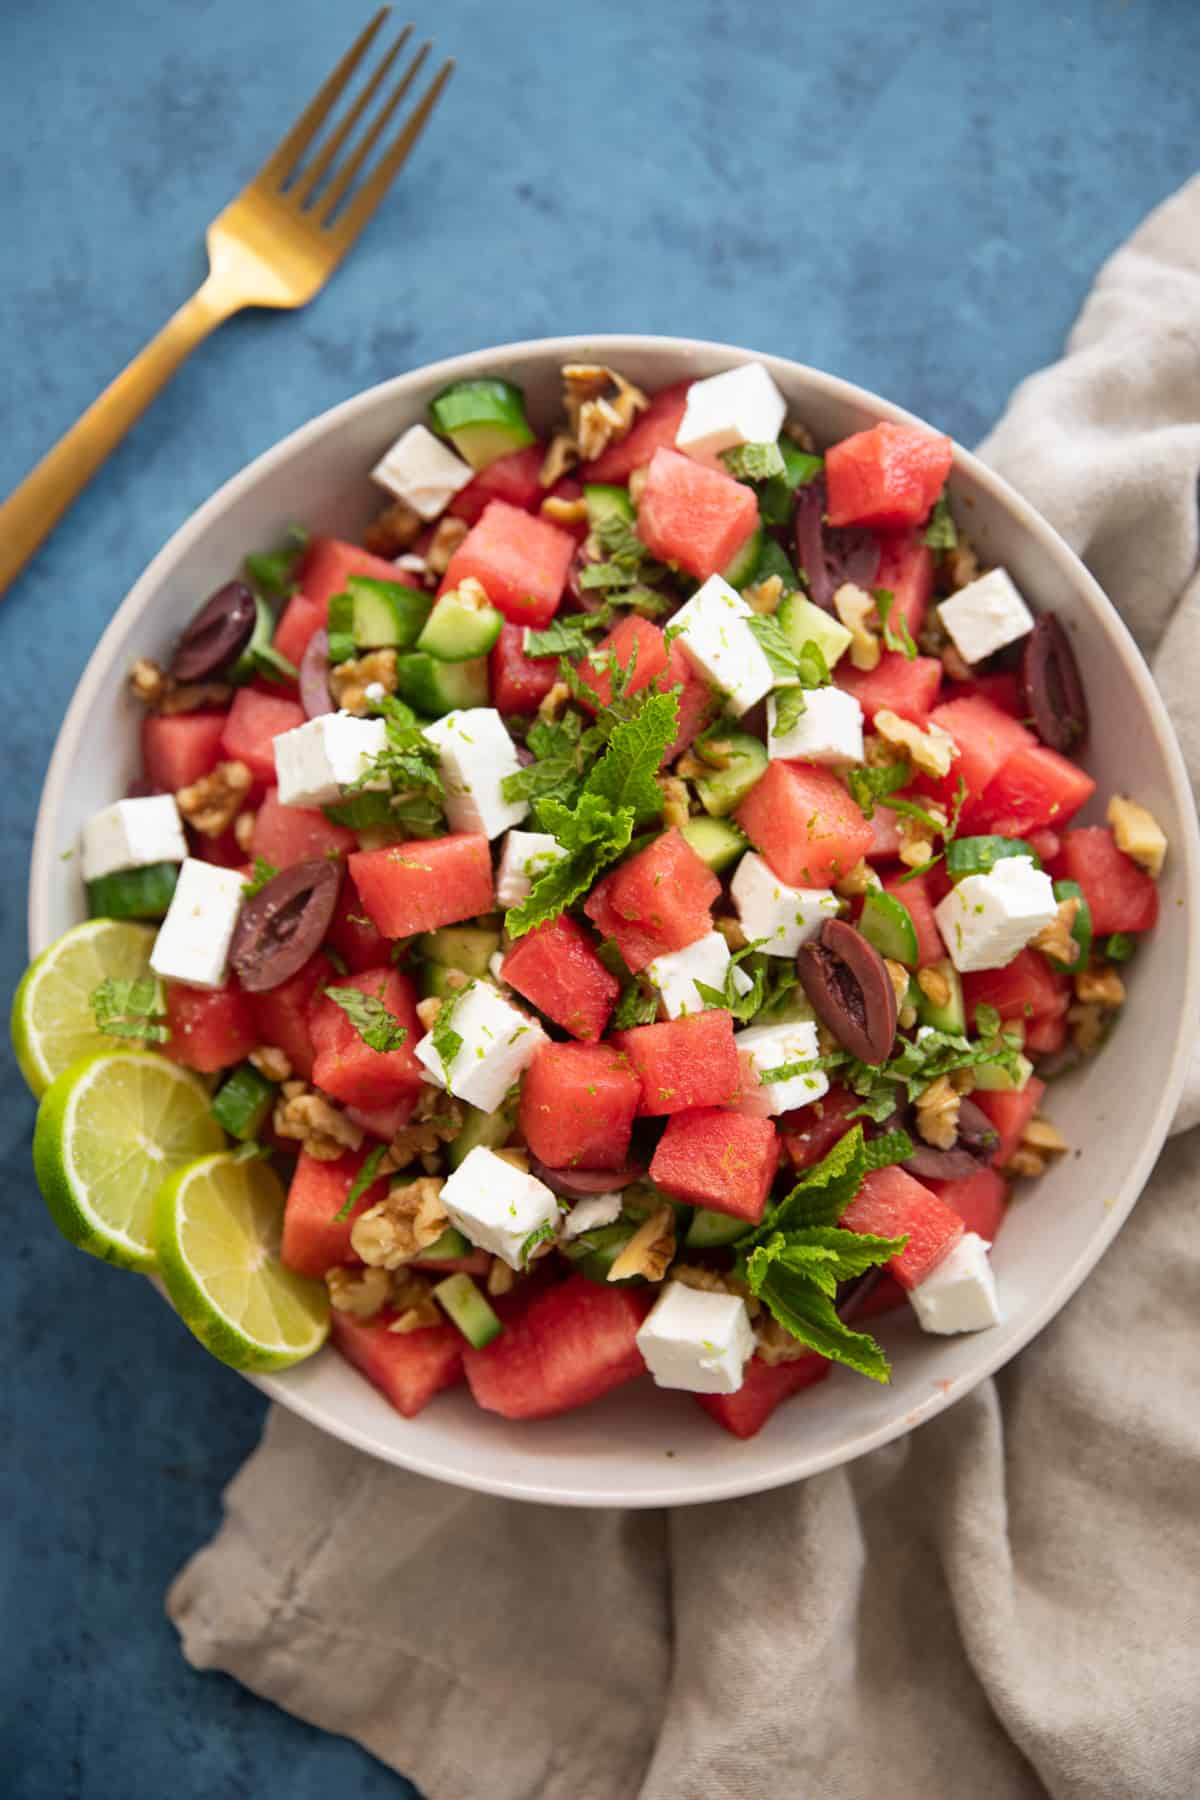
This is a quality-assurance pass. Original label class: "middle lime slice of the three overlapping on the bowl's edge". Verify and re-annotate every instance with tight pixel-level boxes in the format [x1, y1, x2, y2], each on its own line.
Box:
[34, 1049, 225, 1269]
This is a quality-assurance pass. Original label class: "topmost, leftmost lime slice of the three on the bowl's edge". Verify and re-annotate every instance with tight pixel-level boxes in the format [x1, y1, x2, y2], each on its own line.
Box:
[11, 918, 155, 1100]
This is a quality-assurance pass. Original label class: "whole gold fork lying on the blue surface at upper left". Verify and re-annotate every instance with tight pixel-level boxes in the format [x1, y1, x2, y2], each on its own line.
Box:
[0, 5, 453, 594]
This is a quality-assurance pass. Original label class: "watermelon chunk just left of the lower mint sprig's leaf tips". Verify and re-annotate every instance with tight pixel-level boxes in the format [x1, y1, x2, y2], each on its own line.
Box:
[649, 1107, 779, 1224]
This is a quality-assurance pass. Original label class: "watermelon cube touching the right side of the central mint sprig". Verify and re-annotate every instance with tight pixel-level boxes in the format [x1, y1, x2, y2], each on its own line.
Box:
[583, 824, 719, 970]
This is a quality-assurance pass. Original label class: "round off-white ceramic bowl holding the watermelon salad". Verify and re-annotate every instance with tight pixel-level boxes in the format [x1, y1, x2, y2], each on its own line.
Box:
[29, 337, 1200, 1507]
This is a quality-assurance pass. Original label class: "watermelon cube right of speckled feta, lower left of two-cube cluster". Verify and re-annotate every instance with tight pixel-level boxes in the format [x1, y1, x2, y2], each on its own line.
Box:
[520, 1044, 642, 1168]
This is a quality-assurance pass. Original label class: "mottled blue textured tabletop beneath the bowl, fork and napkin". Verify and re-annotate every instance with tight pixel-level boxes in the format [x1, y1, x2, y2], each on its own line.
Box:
[0, 0, 1200, 1800]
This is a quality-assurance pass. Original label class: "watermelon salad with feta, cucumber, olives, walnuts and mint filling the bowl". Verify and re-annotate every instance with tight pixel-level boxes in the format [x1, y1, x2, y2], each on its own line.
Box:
[32, 362, 1166, 1436]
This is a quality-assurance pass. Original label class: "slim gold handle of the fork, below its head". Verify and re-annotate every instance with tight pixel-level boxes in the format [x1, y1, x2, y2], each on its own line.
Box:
[0, 275, 237, 594]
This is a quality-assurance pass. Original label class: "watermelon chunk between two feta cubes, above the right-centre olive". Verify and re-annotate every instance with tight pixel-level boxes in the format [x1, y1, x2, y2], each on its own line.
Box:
[734, 761, 874, 887]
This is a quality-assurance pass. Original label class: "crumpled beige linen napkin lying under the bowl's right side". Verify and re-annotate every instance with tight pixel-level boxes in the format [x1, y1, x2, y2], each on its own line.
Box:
[167, 171, 1200, 1800]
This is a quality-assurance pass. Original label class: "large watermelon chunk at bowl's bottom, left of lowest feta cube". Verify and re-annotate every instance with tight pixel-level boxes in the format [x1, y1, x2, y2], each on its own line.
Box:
[462, 1274, 648, 1418]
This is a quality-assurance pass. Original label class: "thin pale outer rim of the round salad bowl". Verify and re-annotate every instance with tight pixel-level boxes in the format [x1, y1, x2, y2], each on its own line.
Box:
[27, 333, 1200, 1508]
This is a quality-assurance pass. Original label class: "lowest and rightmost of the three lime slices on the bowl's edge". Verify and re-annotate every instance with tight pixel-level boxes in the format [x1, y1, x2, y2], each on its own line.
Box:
[155, 1150, 329, 1370]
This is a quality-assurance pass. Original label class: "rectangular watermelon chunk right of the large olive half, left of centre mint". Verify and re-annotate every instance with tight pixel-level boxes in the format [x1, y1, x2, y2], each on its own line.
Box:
[349, 832, 495, 938]
